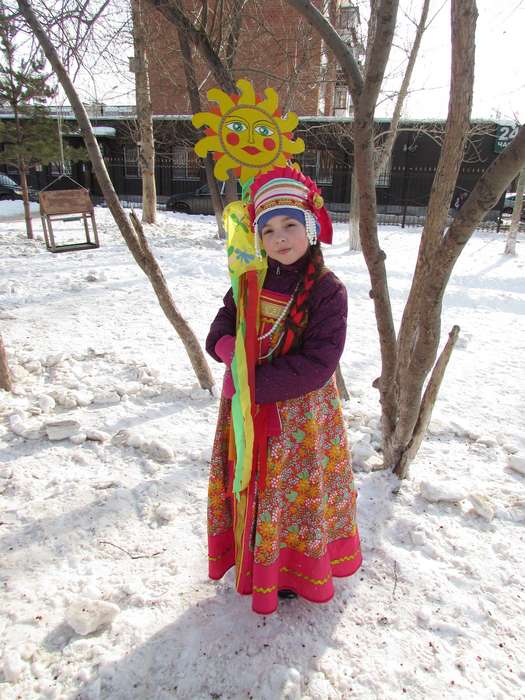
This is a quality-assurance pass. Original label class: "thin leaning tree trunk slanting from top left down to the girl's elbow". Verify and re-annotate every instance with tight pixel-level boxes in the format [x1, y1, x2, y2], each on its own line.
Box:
[18, 0, 214, 392]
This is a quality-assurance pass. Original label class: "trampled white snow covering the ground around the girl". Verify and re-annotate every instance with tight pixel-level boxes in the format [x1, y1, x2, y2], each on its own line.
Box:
[0, 209, 525, 700]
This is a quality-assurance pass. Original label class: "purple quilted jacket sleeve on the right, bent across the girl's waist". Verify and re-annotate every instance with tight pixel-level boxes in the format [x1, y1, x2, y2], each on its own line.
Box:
[255, 272, 348, 403]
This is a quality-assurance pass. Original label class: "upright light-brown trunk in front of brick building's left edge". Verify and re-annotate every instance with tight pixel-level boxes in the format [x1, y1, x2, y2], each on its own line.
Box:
[131, 0, 157, 224]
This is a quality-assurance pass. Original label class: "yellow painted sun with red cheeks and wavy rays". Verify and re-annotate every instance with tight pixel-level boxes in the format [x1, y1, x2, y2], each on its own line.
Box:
[192, 80, 304, 183]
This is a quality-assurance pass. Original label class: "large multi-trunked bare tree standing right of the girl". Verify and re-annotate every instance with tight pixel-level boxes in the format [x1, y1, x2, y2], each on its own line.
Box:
[288, 0, 525, 478]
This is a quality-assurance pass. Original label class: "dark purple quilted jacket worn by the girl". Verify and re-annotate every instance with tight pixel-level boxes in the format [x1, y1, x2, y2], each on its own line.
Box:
[206, 256, 347, 403]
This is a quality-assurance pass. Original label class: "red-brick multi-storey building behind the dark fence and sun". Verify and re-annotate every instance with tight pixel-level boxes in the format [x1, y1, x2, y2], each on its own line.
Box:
[144, 0, 358, 116]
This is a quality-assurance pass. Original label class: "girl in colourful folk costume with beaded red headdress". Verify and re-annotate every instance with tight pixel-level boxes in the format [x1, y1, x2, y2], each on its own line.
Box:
[206, 167, 361, 614]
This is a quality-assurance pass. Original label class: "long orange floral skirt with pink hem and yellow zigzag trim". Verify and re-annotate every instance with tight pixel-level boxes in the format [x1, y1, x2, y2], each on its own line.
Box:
[208, 378, 361, 614]
